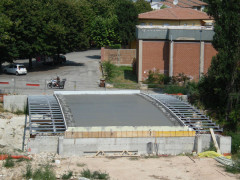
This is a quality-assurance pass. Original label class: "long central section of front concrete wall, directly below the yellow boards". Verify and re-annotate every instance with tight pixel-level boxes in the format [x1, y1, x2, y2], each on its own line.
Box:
[59, 137, 195, 156]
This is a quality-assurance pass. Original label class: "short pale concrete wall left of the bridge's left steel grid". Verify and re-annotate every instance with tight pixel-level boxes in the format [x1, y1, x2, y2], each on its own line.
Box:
[3, 95, 27, 112]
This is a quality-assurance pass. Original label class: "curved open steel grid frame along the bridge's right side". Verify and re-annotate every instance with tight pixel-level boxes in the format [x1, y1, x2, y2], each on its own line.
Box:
[144, 94, 223, 133]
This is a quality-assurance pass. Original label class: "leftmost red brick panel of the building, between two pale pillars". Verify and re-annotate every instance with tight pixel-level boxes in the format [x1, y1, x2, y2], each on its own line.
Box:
[142, 41, 169, 80]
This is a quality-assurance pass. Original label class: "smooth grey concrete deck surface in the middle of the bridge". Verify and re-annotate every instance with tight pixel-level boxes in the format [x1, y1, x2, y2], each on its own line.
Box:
[63, 95, 174, 127]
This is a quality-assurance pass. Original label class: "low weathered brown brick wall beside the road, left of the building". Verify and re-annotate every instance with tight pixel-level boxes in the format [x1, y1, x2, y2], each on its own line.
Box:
[101, 48, 136, 65]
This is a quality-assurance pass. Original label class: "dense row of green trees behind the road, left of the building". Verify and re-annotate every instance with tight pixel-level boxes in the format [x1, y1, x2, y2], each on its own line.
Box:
[0, 0, 151, 65]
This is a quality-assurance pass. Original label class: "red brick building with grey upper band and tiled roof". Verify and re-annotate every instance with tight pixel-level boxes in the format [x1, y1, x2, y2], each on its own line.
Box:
[137, 8, 217, 81]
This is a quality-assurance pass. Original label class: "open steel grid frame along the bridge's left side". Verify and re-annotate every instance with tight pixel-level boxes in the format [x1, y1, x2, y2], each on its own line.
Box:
[28, 95, 66, 135]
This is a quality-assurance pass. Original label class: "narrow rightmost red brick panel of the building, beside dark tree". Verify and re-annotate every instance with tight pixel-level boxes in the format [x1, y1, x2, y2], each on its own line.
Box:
[204, 43, 217, 73]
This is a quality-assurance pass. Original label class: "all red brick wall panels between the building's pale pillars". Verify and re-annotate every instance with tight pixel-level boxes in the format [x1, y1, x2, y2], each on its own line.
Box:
[137, 40, 217, 81]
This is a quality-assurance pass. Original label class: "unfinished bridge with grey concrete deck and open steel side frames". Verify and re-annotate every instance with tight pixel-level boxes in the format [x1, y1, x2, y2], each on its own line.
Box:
[28, 90, 229, 155]
